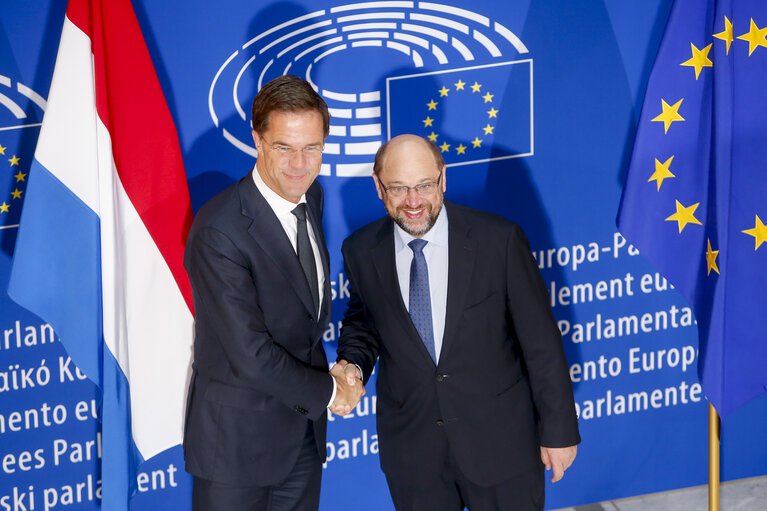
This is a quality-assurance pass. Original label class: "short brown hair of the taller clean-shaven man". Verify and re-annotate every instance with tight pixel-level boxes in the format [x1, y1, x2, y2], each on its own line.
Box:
[251, 75, 330, 137]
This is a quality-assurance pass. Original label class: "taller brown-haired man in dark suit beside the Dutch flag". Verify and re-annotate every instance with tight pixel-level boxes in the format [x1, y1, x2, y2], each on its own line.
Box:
[184, 76, 364, 511]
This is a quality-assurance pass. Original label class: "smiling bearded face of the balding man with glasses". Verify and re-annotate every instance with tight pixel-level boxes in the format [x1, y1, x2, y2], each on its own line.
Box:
[373, 135, 447, 238]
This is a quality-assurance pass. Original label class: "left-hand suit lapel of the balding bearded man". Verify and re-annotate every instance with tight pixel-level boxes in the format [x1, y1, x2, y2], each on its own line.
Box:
[370, 220, 434, 366]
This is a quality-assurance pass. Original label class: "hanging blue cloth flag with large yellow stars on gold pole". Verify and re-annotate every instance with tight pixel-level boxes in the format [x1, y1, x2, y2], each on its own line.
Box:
[618, 0, 767, 417]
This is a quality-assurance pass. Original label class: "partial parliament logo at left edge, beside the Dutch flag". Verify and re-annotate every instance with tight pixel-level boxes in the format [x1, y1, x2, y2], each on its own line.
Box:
[0, 75, 45, 230]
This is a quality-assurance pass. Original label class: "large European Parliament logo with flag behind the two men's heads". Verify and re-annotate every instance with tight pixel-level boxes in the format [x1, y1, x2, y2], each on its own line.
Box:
[208, 1, 533, 177]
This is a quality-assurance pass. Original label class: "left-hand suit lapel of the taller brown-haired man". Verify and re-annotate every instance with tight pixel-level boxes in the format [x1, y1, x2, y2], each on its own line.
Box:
[239, 178, 317, 318]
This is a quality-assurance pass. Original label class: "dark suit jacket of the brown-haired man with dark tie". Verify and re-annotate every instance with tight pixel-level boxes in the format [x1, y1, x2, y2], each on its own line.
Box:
[184, 173, 333, 486]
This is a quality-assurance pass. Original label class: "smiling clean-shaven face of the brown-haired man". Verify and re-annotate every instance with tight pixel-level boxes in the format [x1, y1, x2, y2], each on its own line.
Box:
[253, 110, 325, 203]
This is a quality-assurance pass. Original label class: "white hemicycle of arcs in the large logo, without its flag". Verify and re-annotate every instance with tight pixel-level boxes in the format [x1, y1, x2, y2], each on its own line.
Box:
[208, 1, 528, 177]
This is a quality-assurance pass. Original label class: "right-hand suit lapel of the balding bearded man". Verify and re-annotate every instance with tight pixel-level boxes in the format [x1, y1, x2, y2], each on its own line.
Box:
[440, 201, 477, 360]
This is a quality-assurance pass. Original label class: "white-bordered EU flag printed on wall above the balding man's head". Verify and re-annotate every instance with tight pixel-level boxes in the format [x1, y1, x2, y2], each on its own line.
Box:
[386, 59, 533, 166]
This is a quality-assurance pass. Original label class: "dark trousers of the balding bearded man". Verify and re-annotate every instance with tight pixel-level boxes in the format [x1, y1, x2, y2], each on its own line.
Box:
[386, 448, 545, 511]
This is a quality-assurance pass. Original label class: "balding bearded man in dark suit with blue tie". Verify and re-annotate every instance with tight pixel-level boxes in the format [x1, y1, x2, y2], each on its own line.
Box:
[337, 135, 580, 511]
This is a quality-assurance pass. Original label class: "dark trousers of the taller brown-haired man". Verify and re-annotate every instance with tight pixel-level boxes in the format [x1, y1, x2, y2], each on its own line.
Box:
[192, 421, 322, 511]
